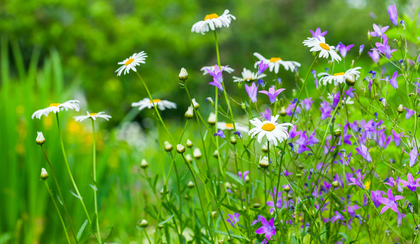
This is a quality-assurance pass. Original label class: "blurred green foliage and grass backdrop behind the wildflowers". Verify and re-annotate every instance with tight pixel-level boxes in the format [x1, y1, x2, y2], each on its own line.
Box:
[0, 0, 418, 243]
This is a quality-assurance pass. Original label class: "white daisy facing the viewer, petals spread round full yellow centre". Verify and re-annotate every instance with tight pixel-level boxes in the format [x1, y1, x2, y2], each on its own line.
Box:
[249, 115, 293, 146]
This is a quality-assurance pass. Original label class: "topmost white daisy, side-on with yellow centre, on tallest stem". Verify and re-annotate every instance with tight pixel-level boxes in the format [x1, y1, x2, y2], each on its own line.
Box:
[191, 9, 236, 35]
